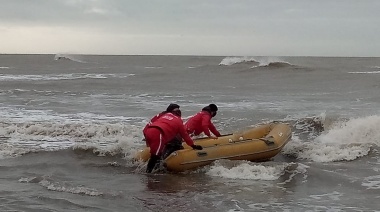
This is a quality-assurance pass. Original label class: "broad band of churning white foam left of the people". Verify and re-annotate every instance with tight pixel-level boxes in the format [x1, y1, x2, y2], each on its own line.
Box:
[0, 109, 145, 158]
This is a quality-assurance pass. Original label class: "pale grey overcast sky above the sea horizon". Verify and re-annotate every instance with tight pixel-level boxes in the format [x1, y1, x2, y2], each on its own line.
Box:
[0, 0, 380, 57]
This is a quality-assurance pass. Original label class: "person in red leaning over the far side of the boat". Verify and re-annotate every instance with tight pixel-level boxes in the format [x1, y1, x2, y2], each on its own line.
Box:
[185, 104, 221, 139]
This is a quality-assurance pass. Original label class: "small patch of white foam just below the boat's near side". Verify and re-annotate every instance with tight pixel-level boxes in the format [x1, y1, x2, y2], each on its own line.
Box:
[206, 161, 289, 180]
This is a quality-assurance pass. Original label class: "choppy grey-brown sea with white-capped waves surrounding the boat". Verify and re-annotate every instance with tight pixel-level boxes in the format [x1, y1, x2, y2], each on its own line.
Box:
[0, 54, 380, 211]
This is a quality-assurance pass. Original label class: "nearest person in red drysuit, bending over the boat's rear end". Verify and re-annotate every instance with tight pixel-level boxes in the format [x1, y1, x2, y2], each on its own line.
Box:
[144, 108, 203, 173]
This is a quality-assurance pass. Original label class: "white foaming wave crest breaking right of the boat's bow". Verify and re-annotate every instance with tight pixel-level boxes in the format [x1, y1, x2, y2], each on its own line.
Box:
[283, 116, 380, 162]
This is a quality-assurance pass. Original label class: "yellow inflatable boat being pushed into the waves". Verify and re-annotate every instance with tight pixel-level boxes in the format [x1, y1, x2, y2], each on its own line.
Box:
[136, 123, 291, 172]
